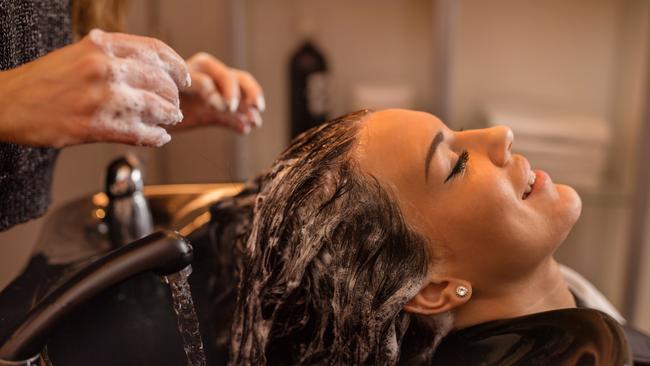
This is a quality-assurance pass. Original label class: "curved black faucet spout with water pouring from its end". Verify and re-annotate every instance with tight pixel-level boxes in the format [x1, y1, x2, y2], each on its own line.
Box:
[0, 230, 193, 365]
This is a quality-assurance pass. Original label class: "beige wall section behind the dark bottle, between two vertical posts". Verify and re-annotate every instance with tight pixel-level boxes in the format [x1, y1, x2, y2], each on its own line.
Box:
[238, 0, 435, 175]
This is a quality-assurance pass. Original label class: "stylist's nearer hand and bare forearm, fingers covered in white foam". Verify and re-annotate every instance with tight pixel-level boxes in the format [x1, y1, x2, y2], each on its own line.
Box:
[0, 29, 190, 147]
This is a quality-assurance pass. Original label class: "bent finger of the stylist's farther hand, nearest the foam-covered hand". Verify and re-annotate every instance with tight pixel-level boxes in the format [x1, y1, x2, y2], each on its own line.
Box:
[187, 52, 241, 112]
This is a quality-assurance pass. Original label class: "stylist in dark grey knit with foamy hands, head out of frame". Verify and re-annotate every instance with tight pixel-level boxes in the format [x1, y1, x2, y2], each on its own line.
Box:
[0, 0, 265, 231]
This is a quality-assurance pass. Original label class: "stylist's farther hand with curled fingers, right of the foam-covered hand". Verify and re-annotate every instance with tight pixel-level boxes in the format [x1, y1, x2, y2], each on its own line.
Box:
[174, 52, 265, 133]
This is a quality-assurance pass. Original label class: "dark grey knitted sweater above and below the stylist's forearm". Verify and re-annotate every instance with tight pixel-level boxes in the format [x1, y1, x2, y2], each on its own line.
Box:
[0, 0, 72, 231]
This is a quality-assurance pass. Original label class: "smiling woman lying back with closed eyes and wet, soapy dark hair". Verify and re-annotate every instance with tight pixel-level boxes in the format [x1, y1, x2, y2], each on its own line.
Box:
[213, 110, 644, 365]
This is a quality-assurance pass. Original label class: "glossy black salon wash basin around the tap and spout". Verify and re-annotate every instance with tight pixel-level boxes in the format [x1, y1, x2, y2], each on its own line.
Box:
[0, 184, 241, 366]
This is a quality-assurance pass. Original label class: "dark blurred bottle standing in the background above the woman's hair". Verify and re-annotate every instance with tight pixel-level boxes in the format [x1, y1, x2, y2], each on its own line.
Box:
[289, 41, 328, 139]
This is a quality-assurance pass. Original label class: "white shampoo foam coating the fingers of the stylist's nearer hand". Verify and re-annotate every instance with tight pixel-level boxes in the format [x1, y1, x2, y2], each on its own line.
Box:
[89, 29, 191, 146]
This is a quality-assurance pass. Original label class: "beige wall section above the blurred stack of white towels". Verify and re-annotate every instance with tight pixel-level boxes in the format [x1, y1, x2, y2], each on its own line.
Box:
[450, 0, 621, 126]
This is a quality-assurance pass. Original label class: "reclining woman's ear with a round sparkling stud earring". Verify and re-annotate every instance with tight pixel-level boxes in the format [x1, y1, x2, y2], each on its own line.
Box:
[404, 277, 472, 315]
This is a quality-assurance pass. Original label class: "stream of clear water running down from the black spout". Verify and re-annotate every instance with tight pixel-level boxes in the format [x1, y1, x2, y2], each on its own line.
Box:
[165, 266, 206, 366]
